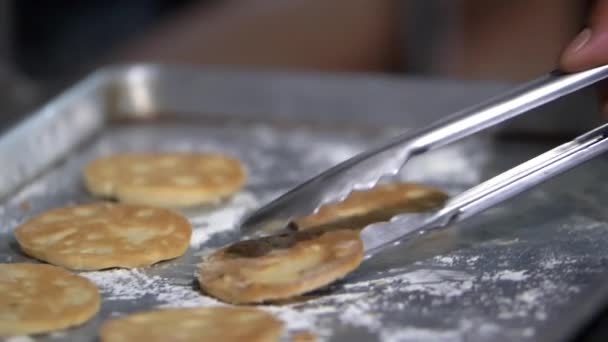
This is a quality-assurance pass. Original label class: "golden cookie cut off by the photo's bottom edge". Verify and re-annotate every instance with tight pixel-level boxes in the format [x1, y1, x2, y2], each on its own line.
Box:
[99, 307, 283, 342]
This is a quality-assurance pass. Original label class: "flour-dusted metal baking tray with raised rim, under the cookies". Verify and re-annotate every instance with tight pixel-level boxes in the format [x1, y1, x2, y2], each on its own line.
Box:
[0, 65, 608, 341]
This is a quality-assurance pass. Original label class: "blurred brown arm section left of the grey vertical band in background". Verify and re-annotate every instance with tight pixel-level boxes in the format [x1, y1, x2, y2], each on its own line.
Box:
[118, 0, 399, 71]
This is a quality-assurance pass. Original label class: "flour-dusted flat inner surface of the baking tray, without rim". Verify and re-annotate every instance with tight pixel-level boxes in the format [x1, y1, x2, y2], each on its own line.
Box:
[0, 116, 608, 342]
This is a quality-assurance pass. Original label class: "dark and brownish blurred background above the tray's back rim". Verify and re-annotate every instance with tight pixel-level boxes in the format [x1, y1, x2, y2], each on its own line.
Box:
[0, 0, 589, 132]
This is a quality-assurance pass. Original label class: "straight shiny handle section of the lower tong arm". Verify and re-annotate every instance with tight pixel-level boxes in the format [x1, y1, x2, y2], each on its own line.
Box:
[434, 124, 608, 226]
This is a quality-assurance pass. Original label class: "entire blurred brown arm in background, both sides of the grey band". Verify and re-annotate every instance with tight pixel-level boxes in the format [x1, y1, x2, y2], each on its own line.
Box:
[113, 0, 584, 80]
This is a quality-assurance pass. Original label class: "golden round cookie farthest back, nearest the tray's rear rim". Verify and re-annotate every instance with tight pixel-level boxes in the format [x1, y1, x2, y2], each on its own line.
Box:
[84, 152, 245, 207]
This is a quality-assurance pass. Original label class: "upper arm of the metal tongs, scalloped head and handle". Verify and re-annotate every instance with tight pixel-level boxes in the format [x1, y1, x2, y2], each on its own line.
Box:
[241, 66, 608, 238]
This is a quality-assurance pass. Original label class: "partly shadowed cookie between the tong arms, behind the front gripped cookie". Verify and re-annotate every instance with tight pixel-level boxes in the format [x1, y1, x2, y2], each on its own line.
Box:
[294, 183, 448, 230]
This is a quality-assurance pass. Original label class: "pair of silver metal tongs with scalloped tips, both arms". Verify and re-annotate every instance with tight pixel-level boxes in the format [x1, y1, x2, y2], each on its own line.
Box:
[240, 65, 608, 255]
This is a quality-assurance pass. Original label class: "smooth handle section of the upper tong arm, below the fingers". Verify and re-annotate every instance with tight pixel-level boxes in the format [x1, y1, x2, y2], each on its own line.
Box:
[395, 65, 608, 154]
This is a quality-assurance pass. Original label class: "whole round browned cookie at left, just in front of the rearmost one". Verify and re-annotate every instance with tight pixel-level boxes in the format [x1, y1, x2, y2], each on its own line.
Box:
[15, 203, 192, 270]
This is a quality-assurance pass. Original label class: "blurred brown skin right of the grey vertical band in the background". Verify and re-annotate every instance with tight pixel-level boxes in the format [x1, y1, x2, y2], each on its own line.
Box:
[447, 0, 587, 81]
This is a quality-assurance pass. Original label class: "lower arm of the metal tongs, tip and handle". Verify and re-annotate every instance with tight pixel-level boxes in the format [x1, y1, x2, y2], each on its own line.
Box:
[361, 124, 608, 258]
